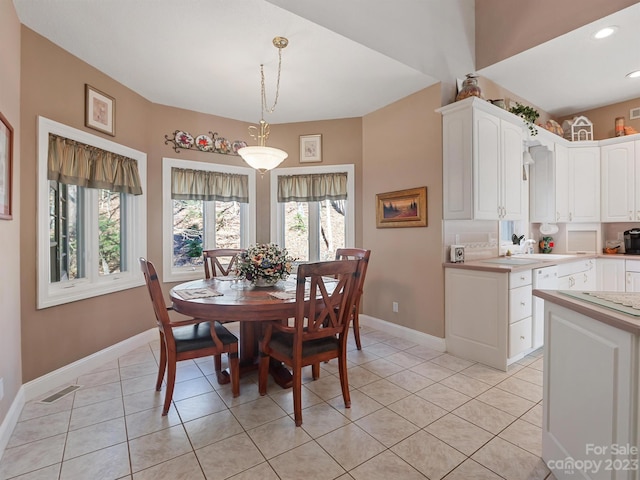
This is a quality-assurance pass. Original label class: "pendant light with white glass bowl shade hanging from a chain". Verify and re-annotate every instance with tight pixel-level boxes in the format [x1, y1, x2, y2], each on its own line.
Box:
[238, 37, 289, 175]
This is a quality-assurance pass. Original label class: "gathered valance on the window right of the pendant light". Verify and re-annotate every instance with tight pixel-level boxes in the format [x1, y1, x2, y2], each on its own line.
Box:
[278, 172, 347, 202]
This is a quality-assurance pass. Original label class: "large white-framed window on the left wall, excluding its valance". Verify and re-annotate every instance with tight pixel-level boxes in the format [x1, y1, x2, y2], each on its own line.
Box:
[37, 117, 147, 308]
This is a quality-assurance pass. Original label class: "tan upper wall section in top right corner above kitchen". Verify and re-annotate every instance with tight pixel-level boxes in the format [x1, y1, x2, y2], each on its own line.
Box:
[476, 0, 638, 70]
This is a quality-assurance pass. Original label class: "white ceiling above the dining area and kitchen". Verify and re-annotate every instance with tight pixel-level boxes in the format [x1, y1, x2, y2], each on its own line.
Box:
[13, 0, 640, 124]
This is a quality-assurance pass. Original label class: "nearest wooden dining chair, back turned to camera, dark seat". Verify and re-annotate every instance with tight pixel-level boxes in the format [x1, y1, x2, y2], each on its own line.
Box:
[258, 260, 360, 426]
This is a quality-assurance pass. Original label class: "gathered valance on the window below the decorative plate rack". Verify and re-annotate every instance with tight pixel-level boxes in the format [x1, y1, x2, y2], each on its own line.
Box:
[171, 167, 249, 203]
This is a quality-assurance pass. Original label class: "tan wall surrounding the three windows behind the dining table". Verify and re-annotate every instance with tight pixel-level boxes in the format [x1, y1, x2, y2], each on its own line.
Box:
[16, 27, 362, 382]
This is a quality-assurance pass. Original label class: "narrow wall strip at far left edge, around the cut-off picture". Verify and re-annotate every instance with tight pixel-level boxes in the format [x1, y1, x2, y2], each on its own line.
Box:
[0, 2, 22, 424]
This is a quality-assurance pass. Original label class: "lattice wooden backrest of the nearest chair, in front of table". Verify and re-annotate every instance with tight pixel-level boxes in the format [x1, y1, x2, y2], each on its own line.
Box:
[293, 260, 360, 340]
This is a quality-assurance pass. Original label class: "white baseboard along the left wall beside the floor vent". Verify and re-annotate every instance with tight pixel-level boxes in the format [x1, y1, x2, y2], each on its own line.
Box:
[0, 328, 158, 458]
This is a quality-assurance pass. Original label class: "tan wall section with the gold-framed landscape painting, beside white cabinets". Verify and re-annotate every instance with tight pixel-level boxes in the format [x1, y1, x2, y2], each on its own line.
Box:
[362, 85, 444, 337]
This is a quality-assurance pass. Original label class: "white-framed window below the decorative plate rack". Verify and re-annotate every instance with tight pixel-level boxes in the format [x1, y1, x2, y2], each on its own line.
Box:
[162, 158, 256, 282]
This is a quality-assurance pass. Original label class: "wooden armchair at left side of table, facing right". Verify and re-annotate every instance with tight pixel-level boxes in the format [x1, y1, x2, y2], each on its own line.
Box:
[139, 257, 240, 415]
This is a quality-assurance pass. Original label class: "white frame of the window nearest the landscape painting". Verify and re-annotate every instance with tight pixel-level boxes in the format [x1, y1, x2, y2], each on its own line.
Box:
[271, 164, 356, 263]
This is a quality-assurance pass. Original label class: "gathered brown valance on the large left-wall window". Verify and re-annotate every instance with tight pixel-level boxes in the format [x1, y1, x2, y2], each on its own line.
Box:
[47, 133, 142, 195]
